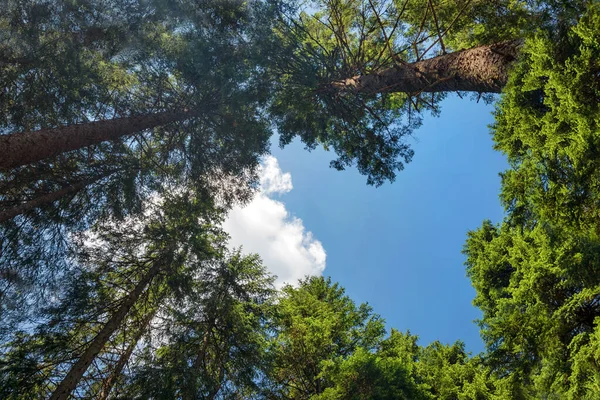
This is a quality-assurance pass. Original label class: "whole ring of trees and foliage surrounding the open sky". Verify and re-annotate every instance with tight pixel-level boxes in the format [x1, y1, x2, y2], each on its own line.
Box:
[0, 0, 600, 400]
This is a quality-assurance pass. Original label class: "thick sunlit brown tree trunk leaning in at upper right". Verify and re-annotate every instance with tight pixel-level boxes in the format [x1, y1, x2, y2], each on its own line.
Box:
[332, 40, 522, 94]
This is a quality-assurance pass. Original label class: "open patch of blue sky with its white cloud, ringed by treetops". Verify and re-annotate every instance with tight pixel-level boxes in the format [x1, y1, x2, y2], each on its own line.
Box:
[226, 97, 507, 353]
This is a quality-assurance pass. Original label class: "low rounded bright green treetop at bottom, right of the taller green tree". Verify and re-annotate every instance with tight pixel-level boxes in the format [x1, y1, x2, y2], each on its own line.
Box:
[314, 329, 510, 400]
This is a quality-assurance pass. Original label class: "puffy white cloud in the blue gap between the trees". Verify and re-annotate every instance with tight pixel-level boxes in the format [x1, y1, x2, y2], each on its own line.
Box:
[224, 156, 326, 286]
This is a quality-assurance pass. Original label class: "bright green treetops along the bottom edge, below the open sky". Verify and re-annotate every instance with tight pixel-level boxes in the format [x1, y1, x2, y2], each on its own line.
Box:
[264, 278, 506, 400]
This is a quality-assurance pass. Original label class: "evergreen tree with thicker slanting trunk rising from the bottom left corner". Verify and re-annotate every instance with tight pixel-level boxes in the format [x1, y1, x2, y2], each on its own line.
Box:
[1, 192, 223, 399]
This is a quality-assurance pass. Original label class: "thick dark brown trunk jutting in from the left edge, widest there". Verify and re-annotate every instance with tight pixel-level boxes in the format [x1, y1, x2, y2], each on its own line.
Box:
[0, 111, 197, 170]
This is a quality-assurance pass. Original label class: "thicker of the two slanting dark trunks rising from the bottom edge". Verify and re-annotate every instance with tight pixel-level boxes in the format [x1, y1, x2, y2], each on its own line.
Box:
[50, 260, 162, 400]
